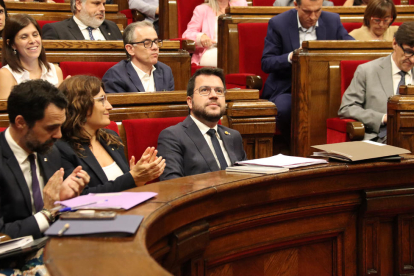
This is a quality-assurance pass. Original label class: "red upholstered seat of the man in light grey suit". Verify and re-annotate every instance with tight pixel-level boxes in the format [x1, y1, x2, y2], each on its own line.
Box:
[326, 60, 369, 144]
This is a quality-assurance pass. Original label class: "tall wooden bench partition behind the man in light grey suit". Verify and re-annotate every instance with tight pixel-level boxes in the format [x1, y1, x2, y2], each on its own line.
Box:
[291, 41, 392, 156]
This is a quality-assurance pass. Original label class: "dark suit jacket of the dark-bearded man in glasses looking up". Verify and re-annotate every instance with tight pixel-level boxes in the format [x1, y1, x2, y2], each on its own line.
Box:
[157, 116, 246, 180]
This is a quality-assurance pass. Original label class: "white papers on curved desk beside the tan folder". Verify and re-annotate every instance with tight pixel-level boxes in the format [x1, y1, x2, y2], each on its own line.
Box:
[236, 154, 328, 168]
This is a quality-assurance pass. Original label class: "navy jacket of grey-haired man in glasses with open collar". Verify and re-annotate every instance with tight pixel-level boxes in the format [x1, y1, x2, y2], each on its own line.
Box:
[102, 60, 174, 93]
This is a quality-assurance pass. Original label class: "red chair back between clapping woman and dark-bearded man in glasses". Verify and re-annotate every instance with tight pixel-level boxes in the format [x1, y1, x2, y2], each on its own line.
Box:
[122, 117, 186, 161]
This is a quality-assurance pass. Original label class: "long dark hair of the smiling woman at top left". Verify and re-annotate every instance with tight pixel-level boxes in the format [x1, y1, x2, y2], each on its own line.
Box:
[1, 13, 50, 72]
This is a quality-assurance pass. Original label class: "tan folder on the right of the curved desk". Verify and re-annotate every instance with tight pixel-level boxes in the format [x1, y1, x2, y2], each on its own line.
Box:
[312, 140, 411, 162]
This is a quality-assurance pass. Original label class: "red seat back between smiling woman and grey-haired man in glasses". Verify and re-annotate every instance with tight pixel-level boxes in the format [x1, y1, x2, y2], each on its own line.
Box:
[59, 61, 117, 79]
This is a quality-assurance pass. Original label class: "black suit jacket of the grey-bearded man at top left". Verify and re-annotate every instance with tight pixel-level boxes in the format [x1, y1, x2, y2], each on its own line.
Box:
[42, 17, 122, 40]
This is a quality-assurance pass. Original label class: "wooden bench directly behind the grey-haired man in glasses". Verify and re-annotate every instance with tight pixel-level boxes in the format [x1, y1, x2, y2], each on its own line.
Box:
[0, 40, 193, 90]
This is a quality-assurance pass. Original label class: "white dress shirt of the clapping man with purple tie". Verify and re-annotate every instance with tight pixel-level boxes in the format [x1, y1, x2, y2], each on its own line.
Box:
[5, 128, 49, 233]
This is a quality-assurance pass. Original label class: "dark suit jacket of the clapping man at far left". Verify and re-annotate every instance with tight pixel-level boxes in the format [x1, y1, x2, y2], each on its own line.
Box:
[0, 132, 61, 238]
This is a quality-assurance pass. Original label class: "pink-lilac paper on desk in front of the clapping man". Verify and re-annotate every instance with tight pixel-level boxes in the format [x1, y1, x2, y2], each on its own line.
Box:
[55, 192, 157, 210]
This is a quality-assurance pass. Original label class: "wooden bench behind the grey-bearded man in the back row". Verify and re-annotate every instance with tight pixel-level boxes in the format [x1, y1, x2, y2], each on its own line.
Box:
[6, 2, 128, 28]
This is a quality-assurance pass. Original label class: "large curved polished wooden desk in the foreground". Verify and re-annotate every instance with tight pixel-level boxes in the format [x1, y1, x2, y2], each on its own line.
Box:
[44, 156, 414, 276]
